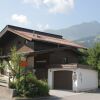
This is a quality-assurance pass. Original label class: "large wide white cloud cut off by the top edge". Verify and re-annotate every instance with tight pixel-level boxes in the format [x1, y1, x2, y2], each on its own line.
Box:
[23, 0, 74, 13]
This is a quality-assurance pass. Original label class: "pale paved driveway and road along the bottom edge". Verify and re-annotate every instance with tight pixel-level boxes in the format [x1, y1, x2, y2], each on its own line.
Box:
[0, 90, 100, 100]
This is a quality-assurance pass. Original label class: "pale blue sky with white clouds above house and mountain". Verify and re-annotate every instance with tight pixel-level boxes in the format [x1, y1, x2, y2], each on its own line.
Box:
[0, 0, 100, 31]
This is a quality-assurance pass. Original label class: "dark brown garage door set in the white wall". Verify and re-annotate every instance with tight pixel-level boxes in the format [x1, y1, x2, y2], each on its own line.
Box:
[54, 70, 72, 90]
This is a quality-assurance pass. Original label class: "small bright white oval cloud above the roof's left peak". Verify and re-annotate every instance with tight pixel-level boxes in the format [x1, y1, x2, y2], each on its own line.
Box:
[11, 14, 28, 24]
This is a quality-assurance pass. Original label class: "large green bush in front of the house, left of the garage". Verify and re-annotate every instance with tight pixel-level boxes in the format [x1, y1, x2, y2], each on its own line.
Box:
[11, 73, 49, 97]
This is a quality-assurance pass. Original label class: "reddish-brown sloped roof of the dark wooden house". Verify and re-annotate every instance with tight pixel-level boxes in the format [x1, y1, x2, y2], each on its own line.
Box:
[0, 27, 86, 49]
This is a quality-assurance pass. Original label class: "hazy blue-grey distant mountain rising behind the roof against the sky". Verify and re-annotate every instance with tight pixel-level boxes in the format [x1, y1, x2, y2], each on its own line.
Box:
[45, 21, 100, 40]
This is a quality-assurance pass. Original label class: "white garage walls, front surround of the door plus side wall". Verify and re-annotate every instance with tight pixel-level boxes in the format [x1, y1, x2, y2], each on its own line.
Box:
[48, 68, 98, 92]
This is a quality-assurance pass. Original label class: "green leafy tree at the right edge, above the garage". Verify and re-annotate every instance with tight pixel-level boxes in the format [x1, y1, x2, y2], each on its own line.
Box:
[87, 43, 100, 70]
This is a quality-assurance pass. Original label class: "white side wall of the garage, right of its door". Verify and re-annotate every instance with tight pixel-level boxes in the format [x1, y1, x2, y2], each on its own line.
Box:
[73, 68, 98, 91]
